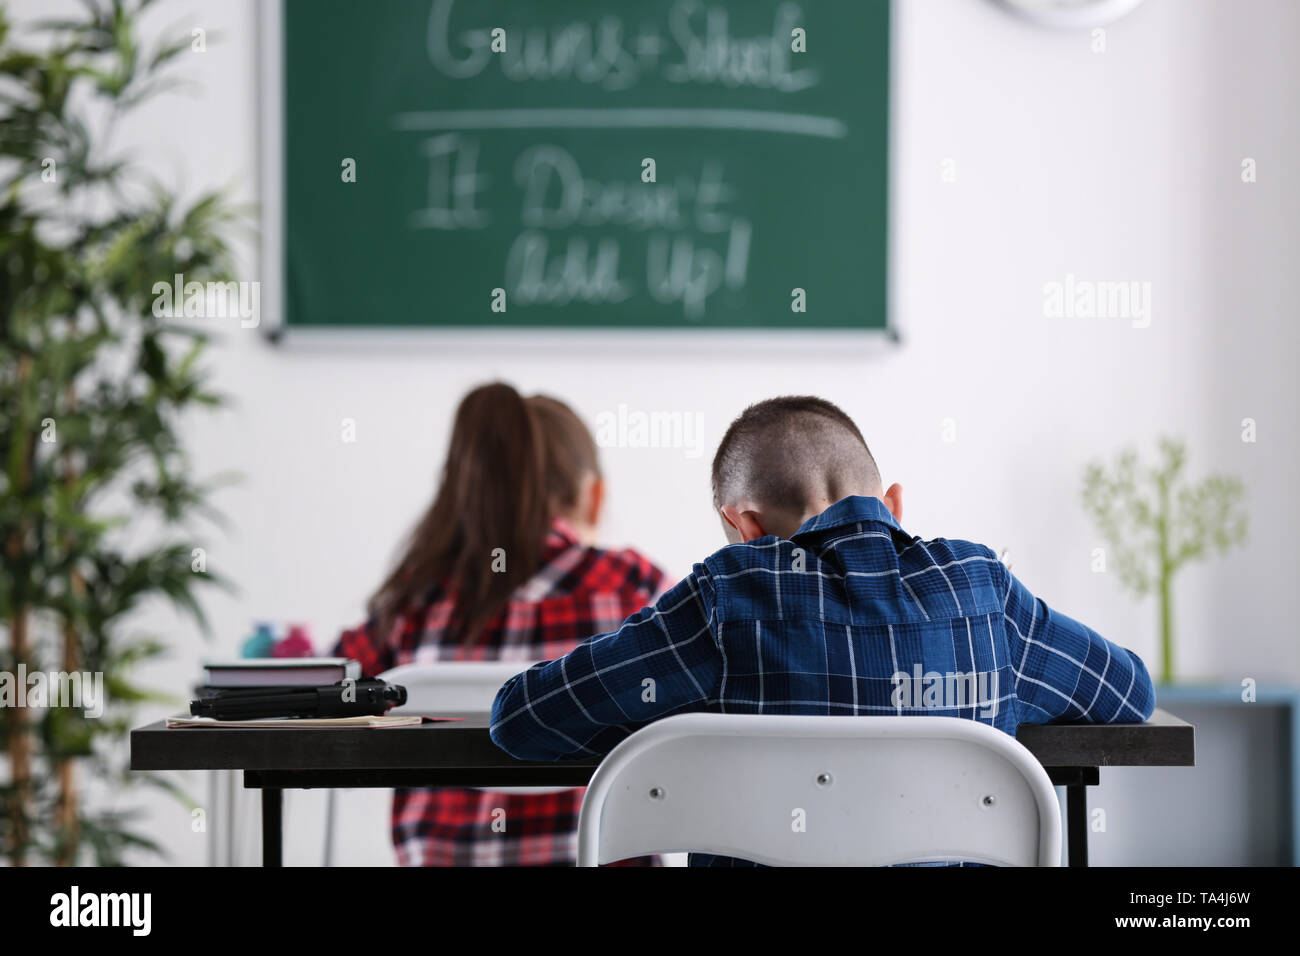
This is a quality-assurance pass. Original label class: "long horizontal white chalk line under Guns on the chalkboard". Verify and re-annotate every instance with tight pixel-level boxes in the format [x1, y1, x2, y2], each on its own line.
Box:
[393, 108, 848, 139]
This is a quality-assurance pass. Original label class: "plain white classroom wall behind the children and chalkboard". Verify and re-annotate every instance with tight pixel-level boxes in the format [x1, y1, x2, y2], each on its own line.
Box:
[14, 0, 1300, 864]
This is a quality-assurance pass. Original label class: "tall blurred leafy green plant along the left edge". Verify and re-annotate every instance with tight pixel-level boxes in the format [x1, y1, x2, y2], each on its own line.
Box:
[0, 0, 243, 865]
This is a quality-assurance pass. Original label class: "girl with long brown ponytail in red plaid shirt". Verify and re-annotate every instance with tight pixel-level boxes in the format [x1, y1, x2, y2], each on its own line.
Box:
[335, 384, 664, 866]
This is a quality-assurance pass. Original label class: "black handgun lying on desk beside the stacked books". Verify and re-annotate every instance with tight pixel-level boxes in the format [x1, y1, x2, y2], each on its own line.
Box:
[190, 678, 406, 721]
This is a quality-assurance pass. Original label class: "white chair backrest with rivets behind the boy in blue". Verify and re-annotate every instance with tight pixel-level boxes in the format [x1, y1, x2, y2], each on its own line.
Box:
[579, 714, 1061, 866]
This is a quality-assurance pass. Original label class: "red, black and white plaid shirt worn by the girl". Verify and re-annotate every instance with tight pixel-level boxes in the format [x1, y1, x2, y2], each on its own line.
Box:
[334, 520, 666, 866]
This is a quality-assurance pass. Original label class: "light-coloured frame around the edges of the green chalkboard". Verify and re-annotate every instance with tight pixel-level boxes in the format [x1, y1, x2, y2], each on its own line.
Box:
[257, 0, 905, 355]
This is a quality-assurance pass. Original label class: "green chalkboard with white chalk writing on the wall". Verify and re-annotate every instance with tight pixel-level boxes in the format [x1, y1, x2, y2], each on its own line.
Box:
[280, 0, 889, 329]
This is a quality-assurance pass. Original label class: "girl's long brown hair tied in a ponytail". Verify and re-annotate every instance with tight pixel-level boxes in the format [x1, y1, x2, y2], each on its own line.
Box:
[369, 382, 599, 644]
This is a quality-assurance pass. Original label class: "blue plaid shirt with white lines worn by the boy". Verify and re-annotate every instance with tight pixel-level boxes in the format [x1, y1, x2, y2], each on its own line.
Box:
[491, 497, 1156, 865]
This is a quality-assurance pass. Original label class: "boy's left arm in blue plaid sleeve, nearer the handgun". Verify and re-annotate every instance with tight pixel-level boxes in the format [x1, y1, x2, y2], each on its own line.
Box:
[491, 564, 722, 760]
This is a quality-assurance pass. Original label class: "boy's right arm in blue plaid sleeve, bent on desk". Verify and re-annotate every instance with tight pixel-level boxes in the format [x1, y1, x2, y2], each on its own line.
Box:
[1002, 571, 1156, 723]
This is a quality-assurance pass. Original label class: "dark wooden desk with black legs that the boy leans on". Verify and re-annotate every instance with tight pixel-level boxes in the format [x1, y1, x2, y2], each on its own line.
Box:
[131, 709, 1196, 866]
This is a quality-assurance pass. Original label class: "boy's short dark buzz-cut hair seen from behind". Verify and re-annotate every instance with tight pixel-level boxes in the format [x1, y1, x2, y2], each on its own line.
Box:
[712, 395, 880, 509]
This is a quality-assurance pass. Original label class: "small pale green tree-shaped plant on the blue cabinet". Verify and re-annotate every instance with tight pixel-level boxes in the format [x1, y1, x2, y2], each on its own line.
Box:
[1083, 438, 1247, 683]
